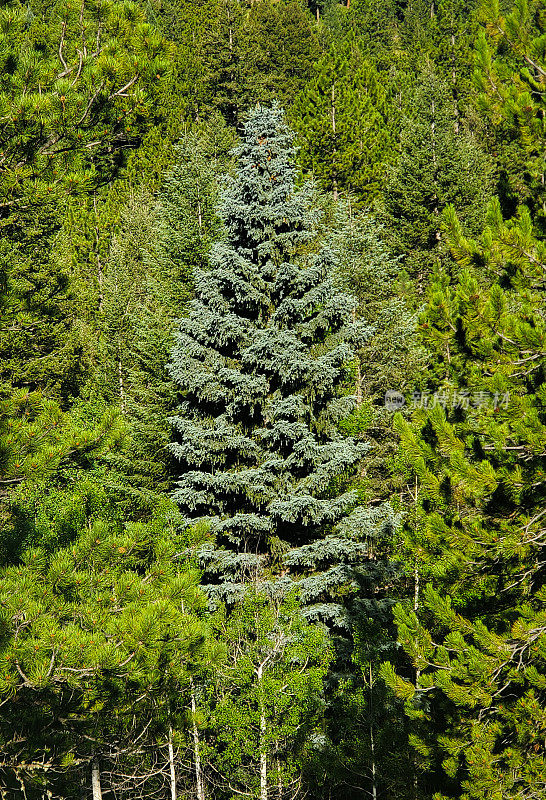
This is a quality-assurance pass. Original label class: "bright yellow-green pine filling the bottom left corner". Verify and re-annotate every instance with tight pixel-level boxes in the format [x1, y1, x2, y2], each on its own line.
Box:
[0, 503, 218, 800]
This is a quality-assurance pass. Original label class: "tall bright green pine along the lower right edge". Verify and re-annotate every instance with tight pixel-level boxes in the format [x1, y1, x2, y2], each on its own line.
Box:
[384, 201, 546, 800]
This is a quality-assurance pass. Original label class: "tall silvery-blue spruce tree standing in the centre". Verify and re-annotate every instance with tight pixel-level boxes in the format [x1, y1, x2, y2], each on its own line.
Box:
[170, 106, 393, 625]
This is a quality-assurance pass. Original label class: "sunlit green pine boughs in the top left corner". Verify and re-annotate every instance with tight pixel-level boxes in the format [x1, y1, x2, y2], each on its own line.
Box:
[0, 2, 168, 226]
